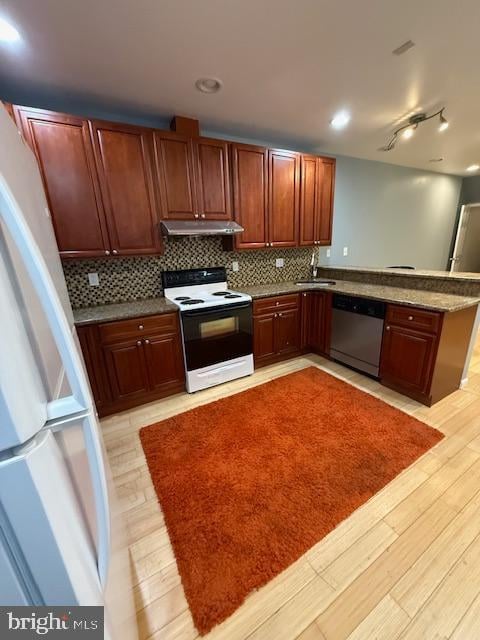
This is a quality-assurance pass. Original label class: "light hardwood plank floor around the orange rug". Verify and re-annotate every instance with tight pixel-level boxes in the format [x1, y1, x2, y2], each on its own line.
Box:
[102, 336, 480, 640]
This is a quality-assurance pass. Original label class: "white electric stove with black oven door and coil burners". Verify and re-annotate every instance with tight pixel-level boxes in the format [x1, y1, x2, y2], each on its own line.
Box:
[162, 267, 253, 393]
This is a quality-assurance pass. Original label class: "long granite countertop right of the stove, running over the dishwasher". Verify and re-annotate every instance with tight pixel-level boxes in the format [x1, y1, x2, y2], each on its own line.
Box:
[242, 280, 480, 311]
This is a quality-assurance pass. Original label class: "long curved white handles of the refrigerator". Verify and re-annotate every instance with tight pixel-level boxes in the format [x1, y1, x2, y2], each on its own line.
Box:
[0, 175, 110, 586]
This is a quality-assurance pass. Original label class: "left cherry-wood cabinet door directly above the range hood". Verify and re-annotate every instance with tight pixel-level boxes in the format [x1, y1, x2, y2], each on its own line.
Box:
[154, 131, 198, 220]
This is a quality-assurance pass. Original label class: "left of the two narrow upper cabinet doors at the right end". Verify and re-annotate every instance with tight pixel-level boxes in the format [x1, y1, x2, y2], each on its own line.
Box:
[299, 156, 321, 246]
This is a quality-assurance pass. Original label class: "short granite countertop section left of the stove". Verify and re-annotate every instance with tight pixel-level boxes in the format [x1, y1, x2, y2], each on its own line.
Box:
[73, 296, 178, 326]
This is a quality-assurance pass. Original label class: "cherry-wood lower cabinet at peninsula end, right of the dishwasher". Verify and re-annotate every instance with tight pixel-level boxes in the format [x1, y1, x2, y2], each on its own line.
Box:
[380, 304, 477, 406]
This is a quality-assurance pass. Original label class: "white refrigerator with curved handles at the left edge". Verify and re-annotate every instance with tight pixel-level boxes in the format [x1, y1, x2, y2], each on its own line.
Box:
[0, 103, 137, 640]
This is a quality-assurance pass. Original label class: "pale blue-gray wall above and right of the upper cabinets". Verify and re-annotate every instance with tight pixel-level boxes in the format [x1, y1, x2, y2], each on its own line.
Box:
[0, 90, 464, 269]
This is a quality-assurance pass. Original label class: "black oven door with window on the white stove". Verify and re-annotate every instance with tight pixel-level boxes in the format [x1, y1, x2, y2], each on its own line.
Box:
[182, 302, 253, 371]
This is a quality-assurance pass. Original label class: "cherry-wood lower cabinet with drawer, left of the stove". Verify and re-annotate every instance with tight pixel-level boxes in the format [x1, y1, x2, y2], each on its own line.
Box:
[77, 313, 185, 416]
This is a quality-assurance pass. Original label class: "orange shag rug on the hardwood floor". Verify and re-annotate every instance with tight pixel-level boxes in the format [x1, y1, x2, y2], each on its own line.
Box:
[140, 367, 443, 634]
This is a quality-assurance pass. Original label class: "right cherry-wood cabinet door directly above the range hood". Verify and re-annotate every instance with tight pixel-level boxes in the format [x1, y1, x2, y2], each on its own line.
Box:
[193, 138, 232, 220]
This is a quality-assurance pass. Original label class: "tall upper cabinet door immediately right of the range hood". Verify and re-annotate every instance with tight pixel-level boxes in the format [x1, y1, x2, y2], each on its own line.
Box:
[232, 144, 268, 249]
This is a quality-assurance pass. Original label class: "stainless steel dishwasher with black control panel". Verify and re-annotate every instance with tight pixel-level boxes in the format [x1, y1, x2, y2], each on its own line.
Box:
[330, 293, 385, 377]
